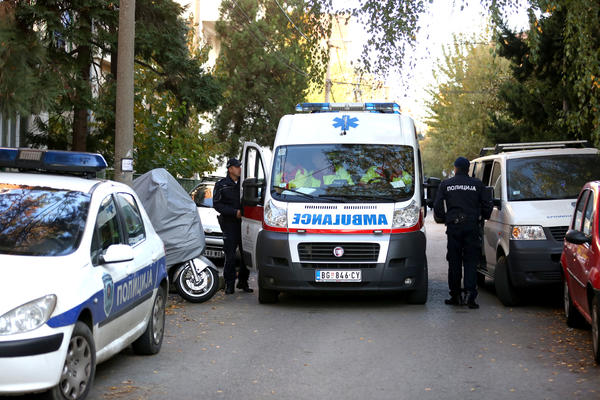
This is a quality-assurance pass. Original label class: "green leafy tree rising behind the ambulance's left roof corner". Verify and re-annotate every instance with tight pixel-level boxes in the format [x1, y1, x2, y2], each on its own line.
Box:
[213, 0, 331, 156]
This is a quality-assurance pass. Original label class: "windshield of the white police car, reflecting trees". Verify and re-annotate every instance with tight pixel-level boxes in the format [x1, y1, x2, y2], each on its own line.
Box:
[0, 183, 90, 256]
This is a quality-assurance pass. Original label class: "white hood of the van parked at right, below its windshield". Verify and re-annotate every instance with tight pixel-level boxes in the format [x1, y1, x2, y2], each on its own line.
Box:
[506, 199, 576, 227]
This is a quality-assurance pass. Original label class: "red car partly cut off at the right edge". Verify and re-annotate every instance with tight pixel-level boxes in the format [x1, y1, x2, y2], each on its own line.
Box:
[560, 181, 600, 364]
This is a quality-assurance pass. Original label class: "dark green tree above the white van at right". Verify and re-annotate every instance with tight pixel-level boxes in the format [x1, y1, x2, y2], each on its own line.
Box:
[489, 0, 600, 143]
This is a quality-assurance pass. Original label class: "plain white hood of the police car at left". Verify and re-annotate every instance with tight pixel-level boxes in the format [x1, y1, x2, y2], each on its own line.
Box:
[0, 254, 82, 315]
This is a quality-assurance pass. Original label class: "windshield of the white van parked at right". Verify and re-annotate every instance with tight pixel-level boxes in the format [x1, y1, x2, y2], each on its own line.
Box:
[507, 154, 600, 201]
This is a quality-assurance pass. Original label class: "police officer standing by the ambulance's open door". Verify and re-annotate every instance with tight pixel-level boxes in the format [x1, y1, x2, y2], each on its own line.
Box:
[213, 158, 253, 294]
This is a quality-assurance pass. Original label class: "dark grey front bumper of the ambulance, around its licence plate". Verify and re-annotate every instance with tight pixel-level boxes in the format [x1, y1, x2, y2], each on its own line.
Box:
[257, 230, 427, 293]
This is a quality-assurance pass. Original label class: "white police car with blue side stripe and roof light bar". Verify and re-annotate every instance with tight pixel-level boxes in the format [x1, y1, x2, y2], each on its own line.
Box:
[0, 148, 168, 399]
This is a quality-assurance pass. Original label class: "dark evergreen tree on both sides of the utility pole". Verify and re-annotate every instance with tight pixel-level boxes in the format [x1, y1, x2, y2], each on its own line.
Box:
[0, 0, 220, 159]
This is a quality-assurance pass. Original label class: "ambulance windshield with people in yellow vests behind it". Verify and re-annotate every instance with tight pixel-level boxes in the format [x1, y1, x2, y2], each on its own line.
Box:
[271, 144, 415, 203]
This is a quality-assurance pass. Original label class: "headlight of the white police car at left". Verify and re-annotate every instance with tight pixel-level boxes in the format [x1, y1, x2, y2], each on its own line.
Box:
[0, 294, 56, 335]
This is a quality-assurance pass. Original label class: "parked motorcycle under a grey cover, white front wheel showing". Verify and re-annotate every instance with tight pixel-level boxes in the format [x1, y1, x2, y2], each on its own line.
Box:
[133, 168, 219, 303]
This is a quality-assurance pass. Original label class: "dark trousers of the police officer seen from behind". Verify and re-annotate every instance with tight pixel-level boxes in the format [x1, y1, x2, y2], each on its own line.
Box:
[446, 223, 481, 300]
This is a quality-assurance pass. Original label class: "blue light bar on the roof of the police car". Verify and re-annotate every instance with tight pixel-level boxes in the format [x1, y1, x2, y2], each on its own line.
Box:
[0, 147, 107, 175]
